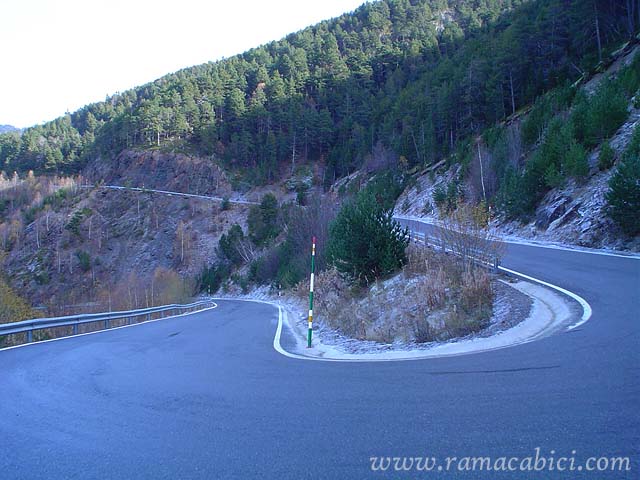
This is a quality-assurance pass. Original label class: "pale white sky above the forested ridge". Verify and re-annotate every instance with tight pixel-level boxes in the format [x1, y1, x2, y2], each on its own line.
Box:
[0, 0, 365, 128]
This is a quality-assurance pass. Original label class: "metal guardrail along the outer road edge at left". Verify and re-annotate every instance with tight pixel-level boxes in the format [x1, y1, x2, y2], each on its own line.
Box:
[0, 300, 215, 343]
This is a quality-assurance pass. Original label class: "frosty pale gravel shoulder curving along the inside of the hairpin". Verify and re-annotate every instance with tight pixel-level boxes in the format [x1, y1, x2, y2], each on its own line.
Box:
[216, 274, 575, 361]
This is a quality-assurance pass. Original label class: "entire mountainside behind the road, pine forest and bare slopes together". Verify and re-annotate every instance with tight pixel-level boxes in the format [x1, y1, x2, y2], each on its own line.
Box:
[0, 0, 640, 314]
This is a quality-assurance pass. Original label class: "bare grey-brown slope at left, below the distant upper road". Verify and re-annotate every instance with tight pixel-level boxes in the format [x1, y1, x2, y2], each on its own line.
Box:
[2, 189, 248, 314]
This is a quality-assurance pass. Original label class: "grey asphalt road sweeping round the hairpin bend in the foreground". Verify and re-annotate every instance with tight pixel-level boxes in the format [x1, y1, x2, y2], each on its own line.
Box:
[0, 226, 640, 480]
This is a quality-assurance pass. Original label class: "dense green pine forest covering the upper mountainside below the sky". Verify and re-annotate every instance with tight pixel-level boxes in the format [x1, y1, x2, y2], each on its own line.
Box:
[0, 0, 640, 185]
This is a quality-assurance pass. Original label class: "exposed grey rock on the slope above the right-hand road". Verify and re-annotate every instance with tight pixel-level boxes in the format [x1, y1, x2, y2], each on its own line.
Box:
[395, 47, 640, 252]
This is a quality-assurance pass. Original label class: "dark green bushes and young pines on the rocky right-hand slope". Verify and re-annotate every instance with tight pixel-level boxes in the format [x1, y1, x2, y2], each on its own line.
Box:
[496, 55, 640, 220]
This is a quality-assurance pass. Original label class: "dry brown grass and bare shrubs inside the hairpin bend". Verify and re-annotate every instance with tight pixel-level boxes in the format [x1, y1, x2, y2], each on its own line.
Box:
[297, 204, 500, 343]
